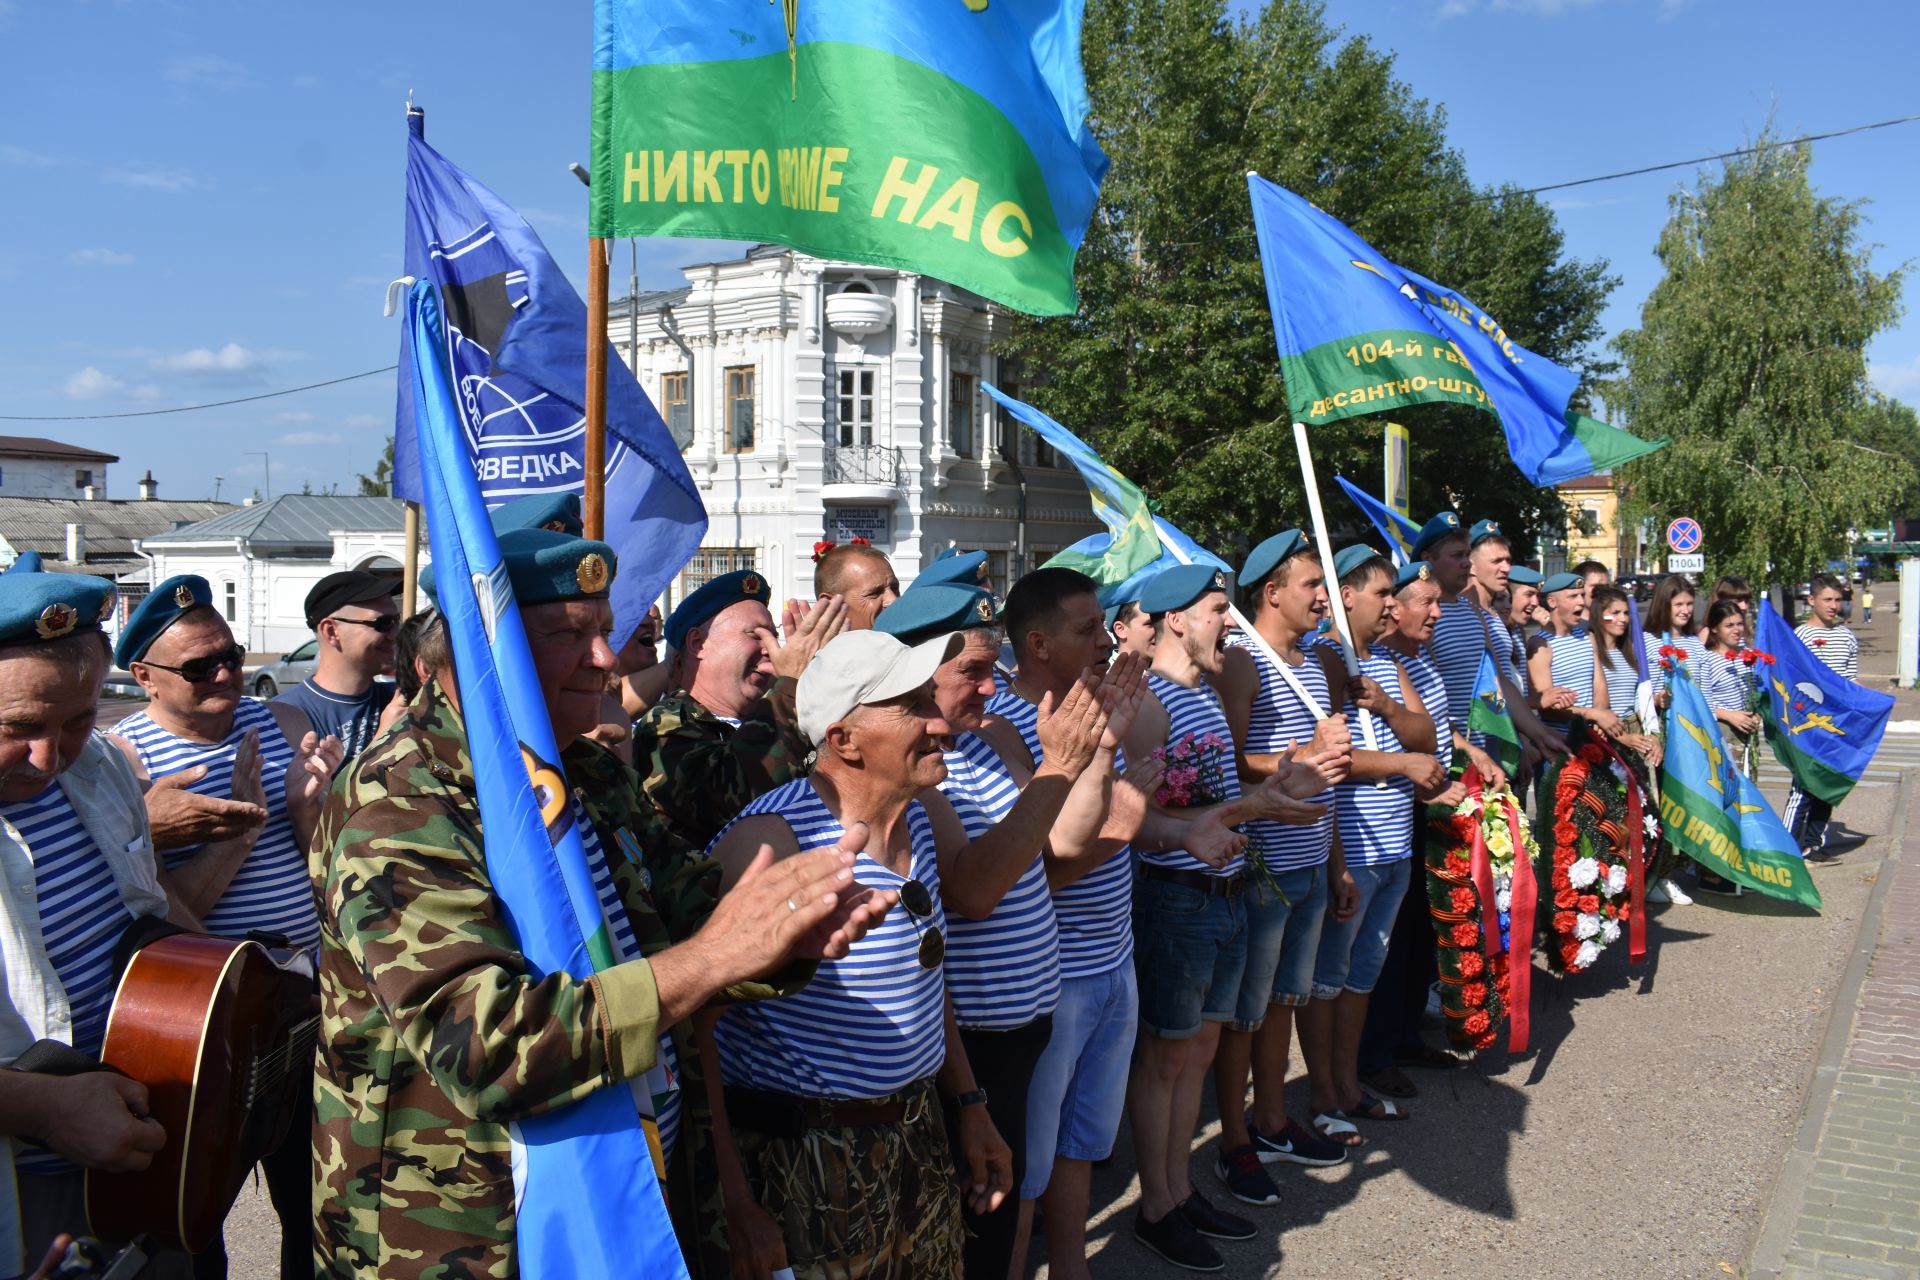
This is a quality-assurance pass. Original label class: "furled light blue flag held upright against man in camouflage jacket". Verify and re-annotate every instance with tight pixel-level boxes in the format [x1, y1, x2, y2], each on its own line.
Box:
[399, 280, 687, 1280]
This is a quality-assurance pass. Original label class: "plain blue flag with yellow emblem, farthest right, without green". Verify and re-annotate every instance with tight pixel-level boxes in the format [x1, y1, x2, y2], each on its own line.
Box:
[1753, 601, 1893, 804]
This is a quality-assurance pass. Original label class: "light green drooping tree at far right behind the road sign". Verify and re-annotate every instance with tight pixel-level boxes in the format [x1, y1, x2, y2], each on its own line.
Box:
[1613, 136, 1914, 583]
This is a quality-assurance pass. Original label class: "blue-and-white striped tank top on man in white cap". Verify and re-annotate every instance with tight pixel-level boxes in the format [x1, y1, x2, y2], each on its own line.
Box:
[714, 777, 947, 1098]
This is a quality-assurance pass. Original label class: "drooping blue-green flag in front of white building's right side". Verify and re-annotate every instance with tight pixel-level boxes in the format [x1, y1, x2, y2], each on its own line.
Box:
[983, 384, 1231, 608]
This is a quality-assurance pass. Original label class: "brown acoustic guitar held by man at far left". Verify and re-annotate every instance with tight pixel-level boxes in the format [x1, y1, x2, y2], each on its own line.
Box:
[86, 933, 319, 1251]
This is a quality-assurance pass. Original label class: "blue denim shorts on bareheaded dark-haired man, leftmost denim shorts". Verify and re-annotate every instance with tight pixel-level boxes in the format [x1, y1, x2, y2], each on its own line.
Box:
[1020, 963, 1140, 1199]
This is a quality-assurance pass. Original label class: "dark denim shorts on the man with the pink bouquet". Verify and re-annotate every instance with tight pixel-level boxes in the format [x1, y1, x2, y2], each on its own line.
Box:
[1133, 875, 1246, 1040]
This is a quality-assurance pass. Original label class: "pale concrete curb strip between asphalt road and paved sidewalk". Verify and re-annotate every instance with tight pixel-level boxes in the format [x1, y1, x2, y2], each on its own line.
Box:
[1745, 770, 1920, 1280]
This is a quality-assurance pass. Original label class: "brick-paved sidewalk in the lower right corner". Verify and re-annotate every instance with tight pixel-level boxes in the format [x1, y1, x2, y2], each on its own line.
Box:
[1751, 771, 1920, 1280]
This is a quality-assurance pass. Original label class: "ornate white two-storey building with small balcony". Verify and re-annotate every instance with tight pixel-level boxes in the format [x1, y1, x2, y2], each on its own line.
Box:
[609, 246, 1100, 612]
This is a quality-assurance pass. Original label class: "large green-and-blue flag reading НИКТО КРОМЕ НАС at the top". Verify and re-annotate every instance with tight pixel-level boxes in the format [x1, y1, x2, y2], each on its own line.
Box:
[591, 0, 1106, 315]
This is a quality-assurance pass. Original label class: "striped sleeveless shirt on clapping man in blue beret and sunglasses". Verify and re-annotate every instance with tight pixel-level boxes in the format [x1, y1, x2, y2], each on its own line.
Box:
[113, 699, 321, 948]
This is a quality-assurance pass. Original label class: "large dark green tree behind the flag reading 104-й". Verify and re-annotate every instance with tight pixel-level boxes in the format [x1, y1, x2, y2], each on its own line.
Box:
[1000, 0, 1613, 551]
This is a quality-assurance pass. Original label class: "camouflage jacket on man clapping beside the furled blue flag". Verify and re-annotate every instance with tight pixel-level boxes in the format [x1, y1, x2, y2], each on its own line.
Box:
[311, 683, 791, 1280]
